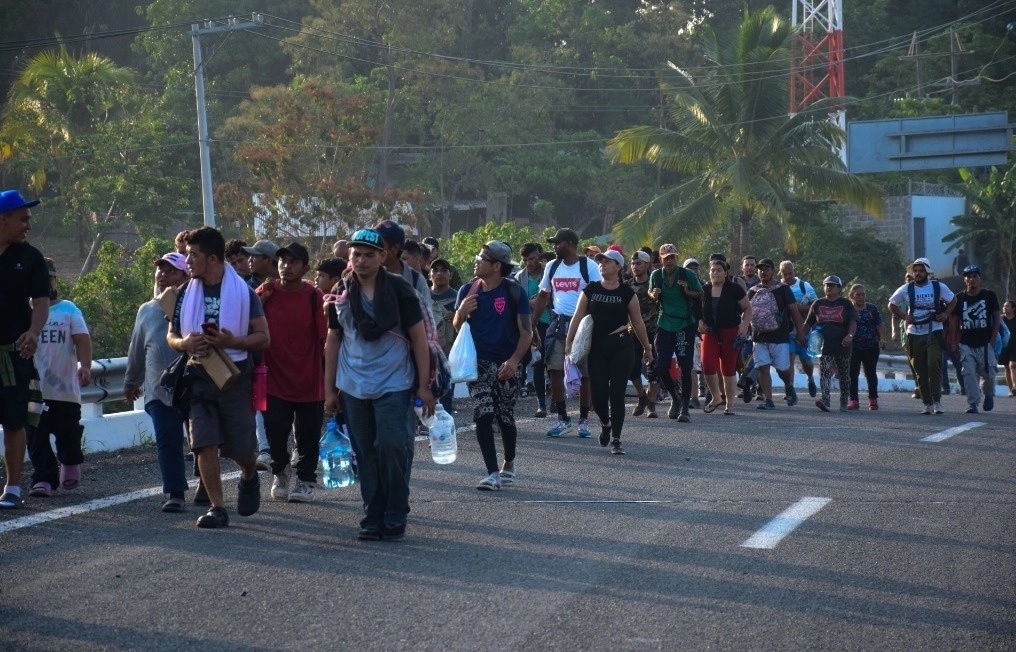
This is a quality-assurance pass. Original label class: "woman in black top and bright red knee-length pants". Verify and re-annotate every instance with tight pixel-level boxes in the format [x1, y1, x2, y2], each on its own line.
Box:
[698, 260, 752, 415]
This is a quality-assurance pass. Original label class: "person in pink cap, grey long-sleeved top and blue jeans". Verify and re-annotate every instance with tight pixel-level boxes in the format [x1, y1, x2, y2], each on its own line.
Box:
[124, 252, 188, 513]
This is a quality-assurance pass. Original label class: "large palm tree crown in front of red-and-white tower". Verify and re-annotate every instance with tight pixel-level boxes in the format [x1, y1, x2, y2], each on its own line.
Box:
[608, 7, 881, 257]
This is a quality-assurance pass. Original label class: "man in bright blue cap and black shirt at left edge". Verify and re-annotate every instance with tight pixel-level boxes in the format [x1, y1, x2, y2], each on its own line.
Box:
[0, 190, 50, 510]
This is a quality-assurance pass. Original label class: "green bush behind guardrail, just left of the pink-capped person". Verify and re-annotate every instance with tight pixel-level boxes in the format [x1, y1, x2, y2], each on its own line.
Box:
[68, 239, 173, 358]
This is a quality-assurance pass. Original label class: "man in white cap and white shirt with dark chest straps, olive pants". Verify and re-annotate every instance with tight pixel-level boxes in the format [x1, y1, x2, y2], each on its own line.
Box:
[889, 258, 956, 414]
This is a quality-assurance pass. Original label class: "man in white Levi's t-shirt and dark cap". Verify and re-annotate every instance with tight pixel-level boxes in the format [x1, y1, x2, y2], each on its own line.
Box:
[532, 229, 600, 437]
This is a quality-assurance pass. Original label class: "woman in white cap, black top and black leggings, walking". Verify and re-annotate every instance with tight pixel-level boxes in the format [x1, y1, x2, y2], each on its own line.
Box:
[565, 250, 652, 455]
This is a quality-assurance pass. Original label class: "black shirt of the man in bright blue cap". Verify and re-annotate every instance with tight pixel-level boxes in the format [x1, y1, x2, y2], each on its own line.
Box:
[0, 243, 50, 344]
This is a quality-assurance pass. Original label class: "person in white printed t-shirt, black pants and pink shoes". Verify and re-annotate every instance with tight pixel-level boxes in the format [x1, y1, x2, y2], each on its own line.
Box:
[27, 258, 91, 498]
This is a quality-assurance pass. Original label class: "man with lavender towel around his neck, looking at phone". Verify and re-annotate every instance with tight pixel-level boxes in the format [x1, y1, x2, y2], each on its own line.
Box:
[167, 226, 270, 528]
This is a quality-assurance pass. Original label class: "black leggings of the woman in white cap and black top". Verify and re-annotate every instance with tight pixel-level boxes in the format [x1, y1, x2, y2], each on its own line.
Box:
[588, 332, 635, 439]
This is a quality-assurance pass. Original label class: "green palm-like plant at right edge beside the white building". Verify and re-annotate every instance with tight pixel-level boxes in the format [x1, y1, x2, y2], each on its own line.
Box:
[942, 166, 1016, 297]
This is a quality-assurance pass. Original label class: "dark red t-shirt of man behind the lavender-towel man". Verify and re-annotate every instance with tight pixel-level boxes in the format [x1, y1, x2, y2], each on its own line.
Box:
[264, 282, 328, 403]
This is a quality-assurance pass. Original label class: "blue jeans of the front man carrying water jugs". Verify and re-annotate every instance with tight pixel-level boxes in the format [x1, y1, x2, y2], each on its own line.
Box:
[340, 389, 417, 528]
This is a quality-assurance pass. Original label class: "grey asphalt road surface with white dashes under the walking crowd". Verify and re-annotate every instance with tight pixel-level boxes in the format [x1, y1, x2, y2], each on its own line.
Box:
[0, 393, 1016, 652]
